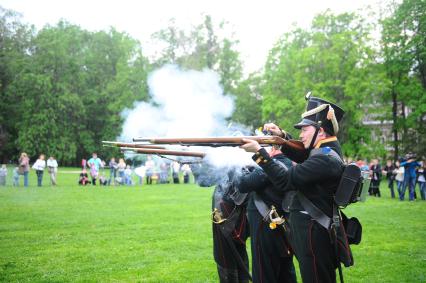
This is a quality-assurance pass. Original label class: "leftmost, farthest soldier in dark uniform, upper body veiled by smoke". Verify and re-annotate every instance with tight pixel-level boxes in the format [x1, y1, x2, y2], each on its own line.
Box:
[196, 164, 251, 283]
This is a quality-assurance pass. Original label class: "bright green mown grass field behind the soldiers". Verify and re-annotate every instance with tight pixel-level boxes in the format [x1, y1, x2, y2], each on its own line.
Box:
[0, 169, 426, 282]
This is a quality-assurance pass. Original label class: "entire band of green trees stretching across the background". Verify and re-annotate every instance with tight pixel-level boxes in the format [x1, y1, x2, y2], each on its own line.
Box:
[0, 0, 426, 164]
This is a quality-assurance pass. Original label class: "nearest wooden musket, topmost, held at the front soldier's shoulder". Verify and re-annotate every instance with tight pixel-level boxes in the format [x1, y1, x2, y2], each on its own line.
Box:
[133, 136, 308, 163]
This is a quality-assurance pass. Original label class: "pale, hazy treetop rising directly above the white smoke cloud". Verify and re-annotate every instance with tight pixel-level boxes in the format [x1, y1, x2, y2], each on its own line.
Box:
[152, 15, 242, 93]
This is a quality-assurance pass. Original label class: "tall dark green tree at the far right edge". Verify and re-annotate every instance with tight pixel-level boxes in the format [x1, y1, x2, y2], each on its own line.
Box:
[382, 0, 426, 159]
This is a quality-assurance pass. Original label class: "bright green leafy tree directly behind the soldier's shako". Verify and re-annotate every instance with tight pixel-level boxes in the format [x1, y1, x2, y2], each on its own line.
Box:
[262, 11, 386, 160]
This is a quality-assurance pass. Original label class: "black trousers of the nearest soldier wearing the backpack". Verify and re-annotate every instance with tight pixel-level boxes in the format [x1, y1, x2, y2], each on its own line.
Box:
[290, 212, 337, 283]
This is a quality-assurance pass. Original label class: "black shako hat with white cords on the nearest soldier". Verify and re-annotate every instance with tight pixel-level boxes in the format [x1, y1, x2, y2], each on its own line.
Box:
[294, 92, 345, 136]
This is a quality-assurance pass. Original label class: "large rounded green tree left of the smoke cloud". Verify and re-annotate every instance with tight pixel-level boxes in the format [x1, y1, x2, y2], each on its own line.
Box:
[9, 21, 149, 164]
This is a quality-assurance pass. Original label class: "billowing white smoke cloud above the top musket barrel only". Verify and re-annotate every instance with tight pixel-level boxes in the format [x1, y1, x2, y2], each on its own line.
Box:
[120, 65, 234, 141]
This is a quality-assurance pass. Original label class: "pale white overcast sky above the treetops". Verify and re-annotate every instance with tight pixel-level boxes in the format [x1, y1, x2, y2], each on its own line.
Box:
[0, 0, 384, 73]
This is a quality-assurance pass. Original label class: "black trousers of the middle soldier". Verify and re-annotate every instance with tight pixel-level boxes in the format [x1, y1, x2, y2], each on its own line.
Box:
[247, 209, 297, 283]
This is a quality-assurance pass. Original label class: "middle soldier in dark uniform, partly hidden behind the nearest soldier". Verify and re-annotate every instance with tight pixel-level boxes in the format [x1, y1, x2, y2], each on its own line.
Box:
[237, 147, 297, 283]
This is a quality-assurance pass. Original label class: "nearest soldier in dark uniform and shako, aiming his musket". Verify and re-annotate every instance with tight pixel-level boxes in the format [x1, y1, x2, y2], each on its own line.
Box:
[242, 97, 344, 282]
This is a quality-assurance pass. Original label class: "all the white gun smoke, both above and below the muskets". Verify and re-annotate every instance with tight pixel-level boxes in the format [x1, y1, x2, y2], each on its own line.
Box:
[118, 65, 254, 185]
